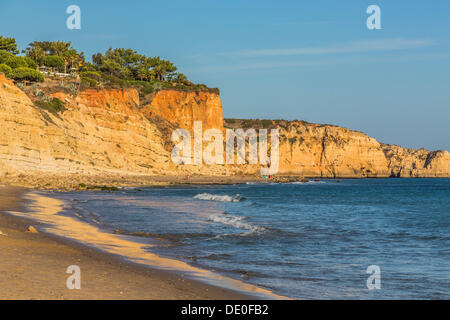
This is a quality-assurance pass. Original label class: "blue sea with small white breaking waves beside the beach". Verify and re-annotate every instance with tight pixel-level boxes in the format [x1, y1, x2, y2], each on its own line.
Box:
[53, 179, 450, 299]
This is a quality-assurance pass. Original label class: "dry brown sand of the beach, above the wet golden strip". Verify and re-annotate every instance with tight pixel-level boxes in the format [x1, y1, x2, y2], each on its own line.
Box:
[0, 186, 252, 299]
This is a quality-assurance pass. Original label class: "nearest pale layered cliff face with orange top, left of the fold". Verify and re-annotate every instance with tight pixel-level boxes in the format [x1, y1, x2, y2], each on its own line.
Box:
[0, 75, 175, 185]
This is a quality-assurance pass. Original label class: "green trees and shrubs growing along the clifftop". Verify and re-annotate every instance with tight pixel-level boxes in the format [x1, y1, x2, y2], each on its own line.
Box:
[0, 36, 219, 96]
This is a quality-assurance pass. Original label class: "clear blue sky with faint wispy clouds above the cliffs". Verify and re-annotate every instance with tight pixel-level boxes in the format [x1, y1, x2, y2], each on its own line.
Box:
[0, 0, 450, 150]
